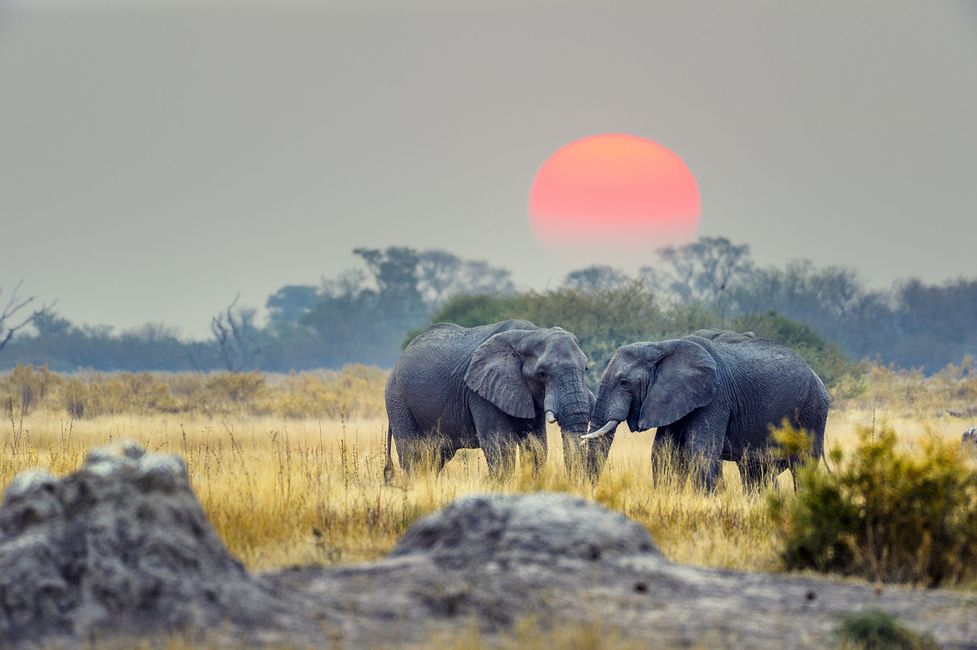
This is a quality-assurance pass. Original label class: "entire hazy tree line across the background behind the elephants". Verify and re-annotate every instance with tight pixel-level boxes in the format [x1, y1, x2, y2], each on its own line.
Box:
[0, 238, 977, 379]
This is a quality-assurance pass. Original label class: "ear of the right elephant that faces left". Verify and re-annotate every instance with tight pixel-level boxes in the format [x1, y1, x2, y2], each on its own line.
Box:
[638, 339, 718, 430]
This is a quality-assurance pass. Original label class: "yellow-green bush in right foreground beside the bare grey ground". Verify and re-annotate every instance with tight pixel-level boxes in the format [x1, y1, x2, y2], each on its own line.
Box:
[770, 428, 977, 586]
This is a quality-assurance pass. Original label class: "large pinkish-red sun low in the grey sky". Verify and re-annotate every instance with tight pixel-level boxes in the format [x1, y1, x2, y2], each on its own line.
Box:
[529, 133, 700, 246]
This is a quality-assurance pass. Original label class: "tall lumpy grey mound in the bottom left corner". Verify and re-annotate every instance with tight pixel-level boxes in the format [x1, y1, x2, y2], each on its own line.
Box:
[0, 443, 320, 645]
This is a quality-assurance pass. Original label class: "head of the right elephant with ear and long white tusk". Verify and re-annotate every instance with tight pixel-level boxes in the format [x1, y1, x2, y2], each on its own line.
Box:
[584, 339, 718, 440]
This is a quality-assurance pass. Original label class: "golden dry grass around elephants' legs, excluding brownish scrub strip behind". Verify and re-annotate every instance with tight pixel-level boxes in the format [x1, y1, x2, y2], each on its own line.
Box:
[0, 406, 970, 570]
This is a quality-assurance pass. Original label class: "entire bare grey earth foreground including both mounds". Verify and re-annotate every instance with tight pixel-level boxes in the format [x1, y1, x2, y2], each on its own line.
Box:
[0, 444, 977, 648]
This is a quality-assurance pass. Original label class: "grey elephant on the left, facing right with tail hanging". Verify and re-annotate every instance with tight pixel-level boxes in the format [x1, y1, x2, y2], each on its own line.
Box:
[384, 320, 607, 479]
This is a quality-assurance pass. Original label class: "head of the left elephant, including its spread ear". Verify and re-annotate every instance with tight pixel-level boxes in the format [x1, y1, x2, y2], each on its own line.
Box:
[465, 327, 594, 435]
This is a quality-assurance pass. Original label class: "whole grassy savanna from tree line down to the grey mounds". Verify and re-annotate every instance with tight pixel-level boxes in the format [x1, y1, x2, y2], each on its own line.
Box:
[0, 364, 977, 571]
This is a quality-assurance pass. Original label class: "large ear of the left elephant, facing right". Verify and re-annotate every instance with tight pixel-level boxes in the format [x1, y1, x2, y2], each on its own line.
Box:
[465, 332, 536, 418]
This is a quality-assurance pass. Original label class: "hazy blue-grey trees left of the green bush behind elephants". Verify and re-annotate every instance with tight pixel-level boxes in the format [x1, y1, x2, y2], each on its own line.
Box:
[0, 246, 515, 372]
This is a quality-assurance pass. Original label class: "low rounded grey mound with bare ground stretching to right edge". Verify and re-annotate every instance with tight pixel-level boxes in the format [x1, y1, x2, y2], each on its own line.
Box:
[280, 493, 977, 648]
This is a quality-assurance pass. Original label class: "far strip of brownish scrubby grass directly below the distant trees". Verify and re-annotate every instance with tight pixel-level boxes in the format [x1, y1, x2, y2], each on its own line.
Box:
[0, 357, 977, 420]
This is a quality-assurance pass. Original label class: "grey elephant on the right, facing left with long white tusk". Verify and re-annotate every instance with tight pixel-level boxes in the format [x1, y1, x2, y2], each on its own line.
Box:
[583, 330, 829, 490]
